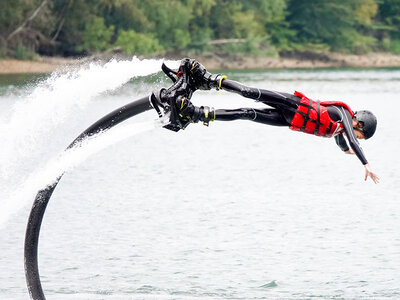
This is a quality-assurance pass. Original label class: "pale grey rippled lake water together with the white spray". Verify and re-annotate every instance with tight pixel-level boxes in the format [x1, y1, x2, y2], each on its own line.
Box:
[0, 62, 400, 299]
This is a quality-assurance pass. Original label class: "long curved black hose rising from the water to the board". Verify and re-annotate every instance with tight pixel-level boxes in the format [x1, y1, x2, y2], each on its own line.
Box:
[24, 97, 152, 300]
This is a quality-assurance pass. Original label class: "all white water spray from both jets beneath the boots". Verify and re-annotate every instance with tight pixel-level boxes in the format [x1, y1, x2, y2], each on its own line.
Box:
[0, 57, 176, 227]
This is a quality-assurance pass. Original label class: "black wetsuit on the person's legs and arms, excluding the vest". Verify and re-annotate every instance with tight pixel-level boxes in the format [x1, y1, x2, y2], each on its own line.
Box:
[215, 79, 368, 165]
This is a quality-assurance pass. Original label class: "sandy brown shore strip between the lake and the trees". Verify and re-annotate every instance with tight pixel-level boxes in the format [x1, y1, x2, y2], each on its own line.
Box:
[0, 53, 400, 74]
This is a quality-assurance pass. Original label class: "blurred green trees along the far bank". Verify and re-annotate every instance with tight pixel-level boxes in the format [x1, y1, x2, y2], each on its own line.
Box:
[0, 0, 400, 59]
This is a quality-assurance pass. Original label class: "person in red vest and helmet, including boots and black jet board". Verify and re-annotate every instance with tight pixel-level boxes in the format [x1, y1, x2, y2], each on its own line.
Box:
[150, 59, 379, 183]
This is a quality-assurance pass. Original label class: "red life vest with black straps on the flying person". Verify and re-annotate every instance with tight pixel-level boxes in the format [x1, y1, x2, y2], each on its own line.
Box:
[289, 91, 354, 137]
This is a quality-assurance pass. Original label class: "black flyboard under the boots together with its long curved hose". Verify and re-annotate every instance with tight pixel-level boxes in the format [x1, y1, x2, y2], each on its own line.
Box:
[24, 59, 196, 300]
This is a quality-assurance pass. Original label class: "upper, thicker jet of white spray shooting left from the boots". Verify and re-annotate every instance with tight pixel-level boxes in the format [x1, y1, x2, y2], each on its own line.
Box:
[0, 57, 174, 177]
